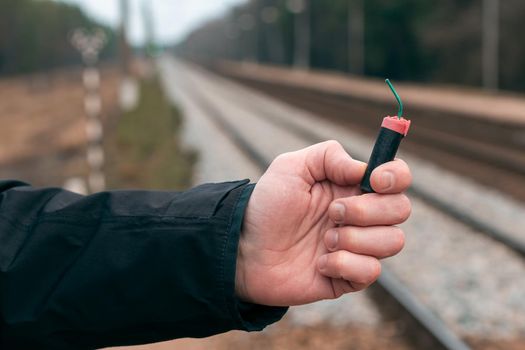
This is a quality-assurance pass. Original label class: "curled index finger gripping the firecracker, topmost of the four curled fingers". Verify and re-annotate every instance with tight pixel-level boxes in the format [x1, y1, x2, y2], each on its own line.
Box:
[370, 159, 412, 193]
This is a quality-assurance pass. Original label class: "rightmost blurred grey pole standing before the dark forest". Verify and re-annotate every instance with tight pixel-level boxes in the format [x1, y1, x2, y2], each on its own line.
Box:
[482, 0, 500, 90]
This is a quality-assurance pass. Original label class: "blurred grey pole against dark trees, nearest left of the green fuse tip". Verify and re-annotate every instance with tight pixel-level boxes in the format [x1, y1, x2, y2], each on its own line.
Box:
[348, 0, 365, 75]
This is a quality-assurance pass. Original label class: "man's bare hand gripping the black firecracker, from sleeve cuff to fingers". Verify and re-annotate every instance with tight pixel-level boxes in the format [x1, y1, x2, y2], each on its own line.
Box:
[236, 141, 412, 306]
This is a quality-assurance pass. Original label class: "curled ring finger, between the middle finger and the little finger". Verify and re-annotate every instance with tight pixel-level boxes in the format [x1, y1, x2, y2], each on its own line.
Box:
[324, 226, 405, 259]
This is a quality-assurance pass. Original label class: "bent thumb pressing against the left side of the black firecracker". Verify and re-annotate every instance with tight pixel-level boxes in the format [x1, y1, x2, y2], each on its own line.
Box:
[299, 141, 366, 186]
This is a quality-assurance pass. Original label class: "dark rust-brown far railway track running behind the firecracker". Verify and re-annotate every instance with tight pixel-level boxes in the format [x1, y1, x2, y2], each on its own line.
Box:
[223, 72, 525, 201]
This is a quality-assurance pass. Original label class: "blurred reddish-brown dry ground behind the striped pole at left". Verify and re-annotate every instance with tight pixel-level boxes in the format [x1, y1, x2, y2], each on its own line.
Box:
[0, 68, 119, 186]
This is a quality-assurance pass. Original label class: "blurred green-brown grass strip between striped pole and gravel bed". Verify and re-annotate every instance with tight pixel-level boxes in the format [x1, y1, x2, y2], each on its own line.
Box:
[107, 79, 196, 190]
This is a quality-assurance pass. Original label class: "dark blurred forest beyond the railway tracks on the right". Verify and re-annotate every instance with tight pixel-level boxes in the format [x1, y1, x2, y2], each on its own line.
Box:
[176, 0, 525, 91]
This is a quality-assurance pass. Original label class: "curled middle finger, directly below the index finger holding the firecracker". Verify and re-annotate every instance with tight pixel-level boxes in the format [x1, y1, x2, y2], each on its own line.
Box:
[328, 193, 412, 226]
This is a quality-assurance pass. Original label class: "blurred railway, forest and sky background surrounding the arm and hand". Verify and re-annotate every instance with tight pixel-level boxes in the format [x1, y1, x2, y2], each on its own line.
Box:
[0, 0, 525, 349]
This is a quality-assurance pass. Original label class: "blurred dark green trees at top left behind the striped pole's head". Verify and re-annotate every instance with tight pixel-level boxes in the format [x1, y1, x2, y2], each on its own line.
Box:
[0, 0, 117, 76]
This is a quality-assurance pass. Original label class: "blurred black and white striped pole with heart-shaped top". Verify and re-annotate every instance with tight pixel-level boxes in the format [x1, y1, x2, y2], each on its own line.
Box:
[71, 29, 106, 193]
